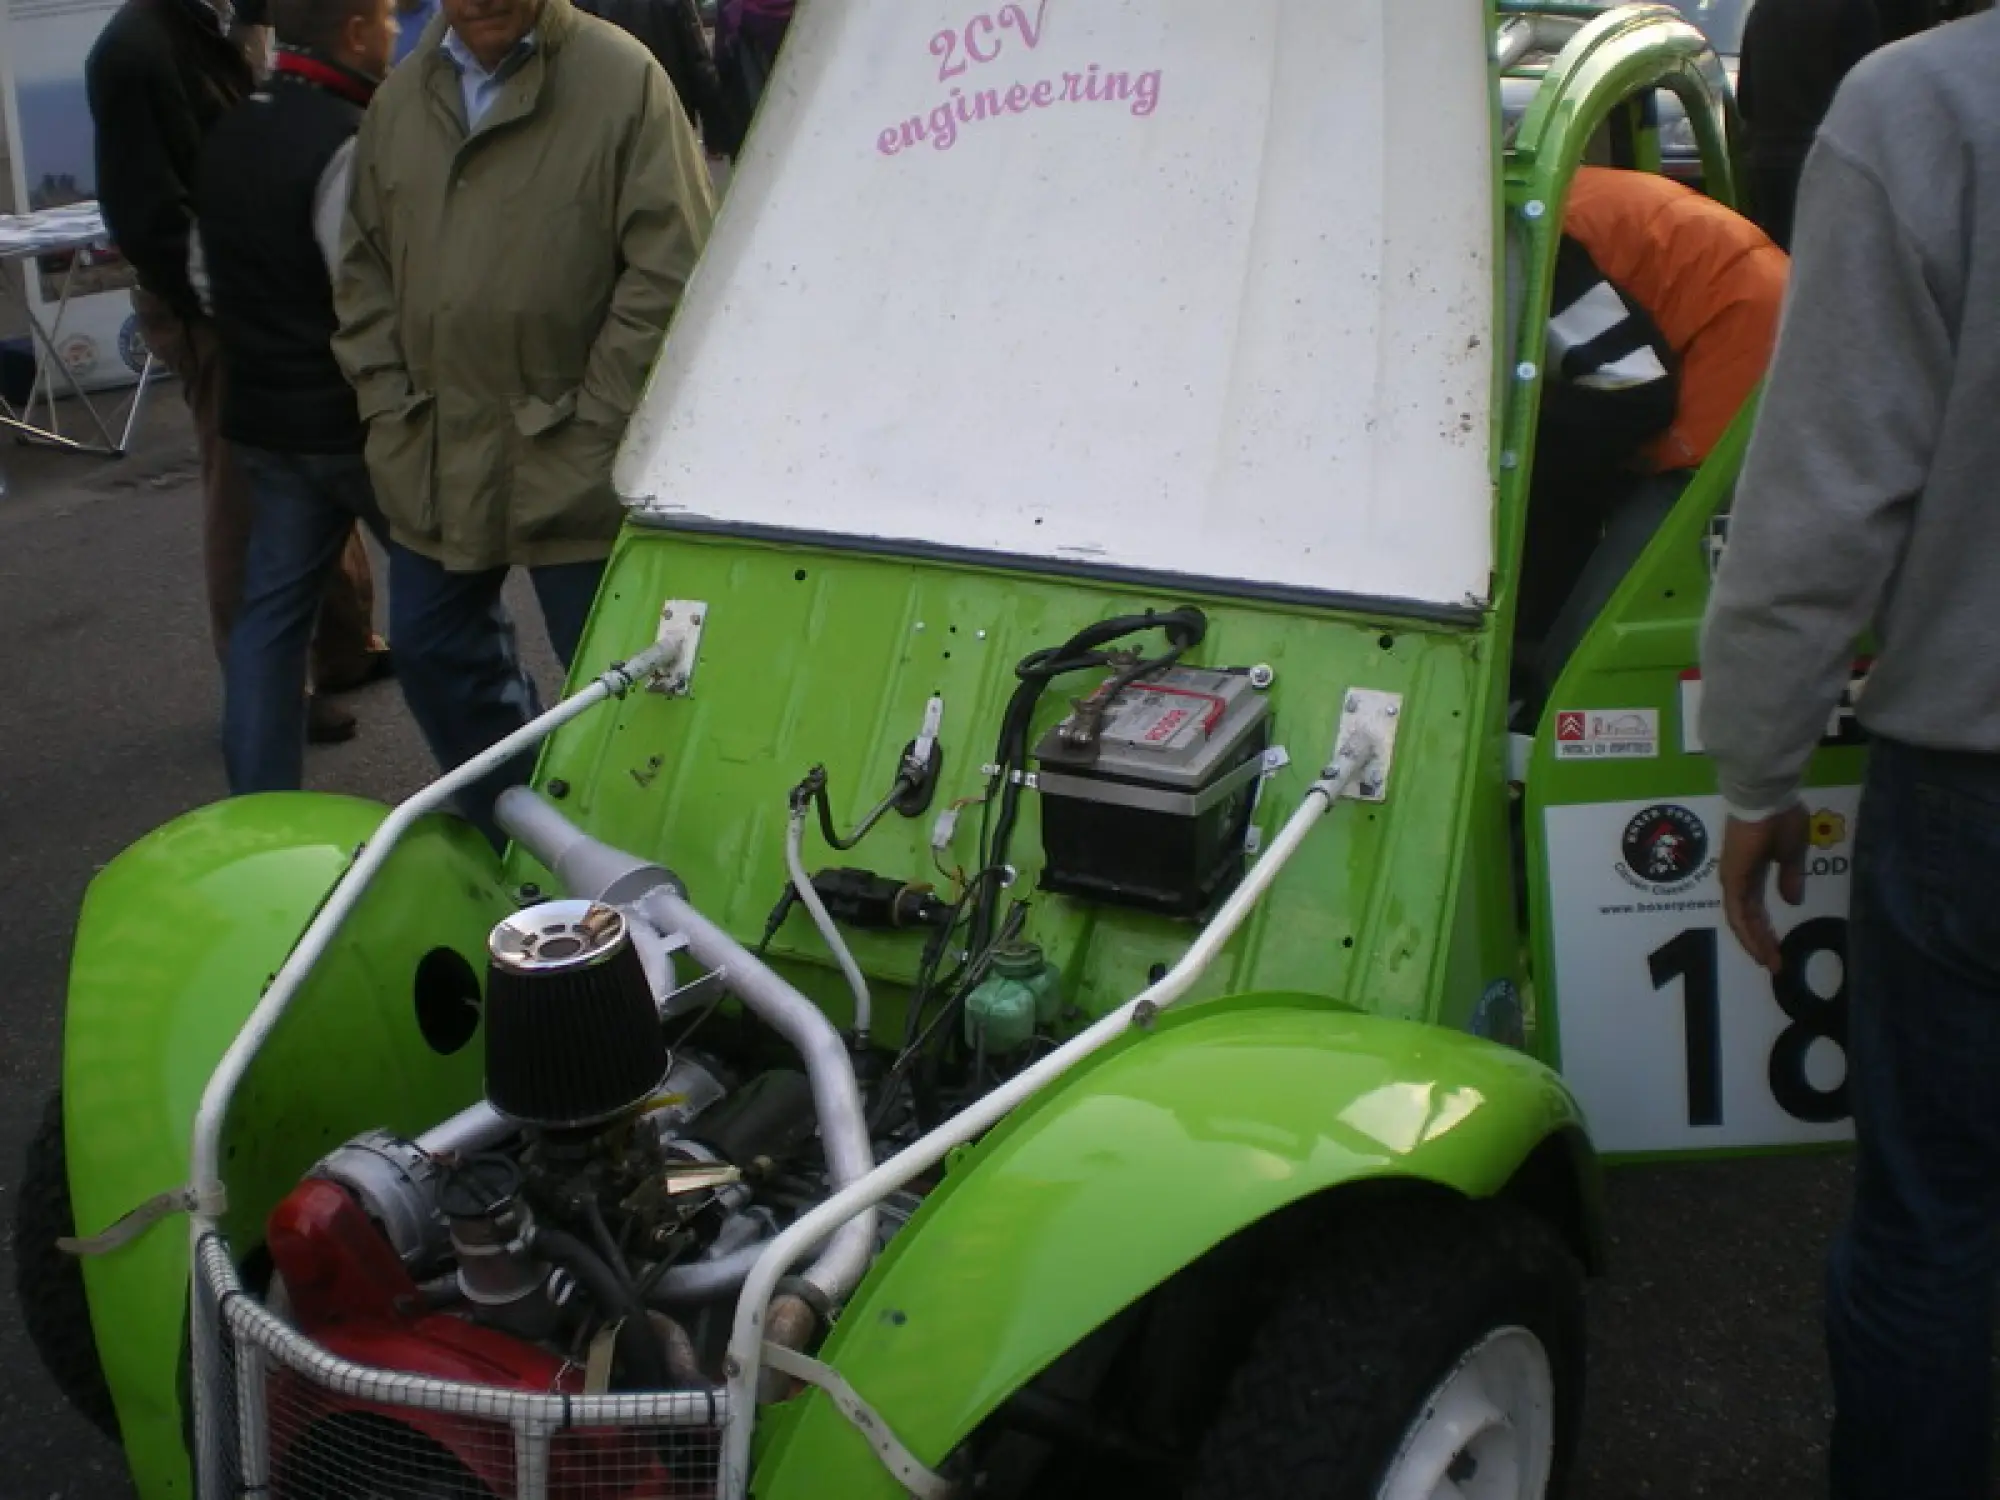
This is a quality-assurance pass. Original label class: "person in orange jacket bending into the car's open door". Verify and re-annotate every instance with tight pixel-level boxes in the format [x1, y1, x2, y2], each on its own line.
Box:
[1516, 166, 1790, 686]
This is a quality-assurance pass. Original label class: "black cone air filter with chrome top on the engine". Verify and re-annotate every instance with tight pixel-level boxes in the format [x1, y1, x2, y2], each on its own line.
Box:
[486, 902, 672, 1130]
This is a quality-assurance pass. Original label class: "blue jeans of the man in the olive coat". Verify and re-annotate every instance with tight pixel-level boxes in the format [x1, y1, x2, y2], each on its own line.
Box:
[388, 546, 604, 848]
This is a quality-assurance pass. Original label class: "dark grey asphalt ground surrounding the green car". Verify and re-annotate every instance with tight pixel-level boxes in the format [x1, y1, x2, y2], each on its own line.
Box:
[0, 388, 1844, 1500]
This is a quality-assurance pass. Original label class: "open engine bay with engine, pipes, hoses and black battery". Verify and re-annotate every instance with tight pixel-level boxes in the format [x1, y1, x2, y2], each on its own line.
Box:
[266, 608, 1282, 1394]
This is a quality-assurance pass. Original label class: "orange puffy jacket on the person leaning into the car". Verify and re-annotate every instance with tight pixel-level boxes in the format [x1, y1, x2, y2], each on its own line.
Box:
[1562, 166, 1792, 472]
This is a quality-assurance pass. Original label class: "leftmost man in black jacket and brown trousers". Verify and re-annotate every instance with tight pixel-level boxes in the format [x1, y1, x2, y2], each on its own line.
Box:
[84, 0, 386, 740]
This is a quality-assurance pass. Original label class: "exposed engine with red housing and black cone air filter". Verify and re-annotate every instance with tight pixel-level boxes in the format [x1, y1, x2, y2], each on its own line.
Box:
[268, 900, 906, 1392]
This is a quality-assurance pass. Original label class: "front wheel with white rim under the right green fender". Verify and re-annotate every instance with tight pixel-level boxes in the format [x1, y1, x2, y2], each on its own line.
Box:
[1188, 1202, 1584, 1500]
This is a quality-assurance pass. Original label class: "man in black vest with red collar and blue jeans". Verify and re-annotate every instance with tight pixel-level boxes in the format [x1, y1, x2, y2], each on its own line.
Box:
[192, 0, 396, 796]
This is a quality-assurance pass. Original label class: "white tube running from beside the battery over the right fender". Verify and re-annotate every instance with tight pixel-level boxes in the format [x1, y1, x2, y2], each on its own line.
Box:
[720, 726, 1380, 1500]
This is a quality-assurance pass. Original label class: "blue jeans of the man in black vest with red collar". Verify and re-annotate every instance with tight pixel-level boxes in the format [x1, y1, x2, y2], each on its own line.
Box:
[222, 444, 386, 796]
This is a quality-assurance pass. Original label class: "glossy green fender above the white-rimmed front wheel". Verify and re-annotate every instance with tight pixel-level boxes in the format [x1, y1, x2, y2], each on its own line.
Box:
[756, 994, 1596, 1500]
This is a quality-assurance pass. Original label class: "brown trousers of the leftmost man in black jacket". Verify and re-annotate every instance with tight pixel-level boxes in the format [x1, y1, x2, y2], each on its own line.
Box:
[132, 288, 374, 690]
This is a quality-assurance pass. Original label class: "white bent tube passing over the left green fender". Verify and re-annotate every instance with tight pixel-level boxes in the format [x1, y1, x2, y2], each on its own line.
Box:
[188, 640, 682, 1496]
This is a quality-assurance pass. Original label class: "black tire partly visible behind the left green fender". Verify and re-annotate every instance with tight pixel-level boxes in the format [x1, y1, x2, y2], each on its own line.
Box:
[14, 1088, 118, 1438]
